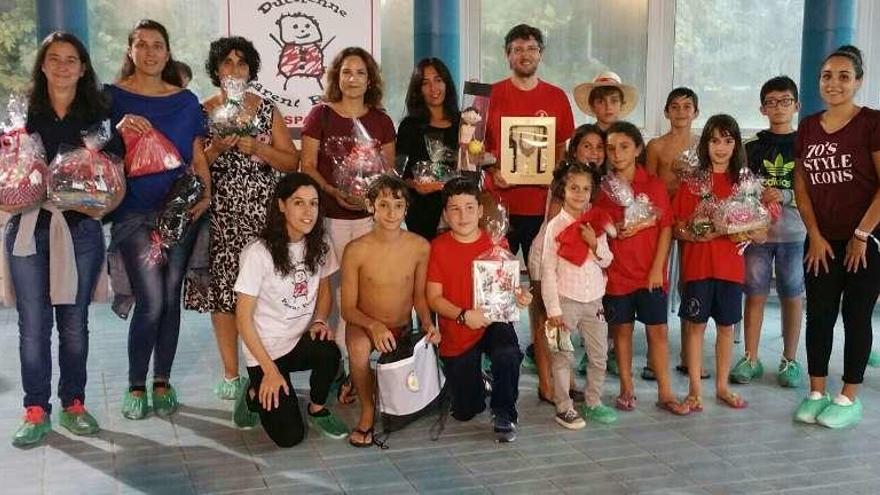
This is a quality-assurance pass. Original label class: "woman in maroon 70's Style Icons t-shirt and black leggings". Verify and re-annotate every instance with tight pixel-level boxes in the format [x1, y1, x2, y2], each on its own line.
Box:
[795, 46, 880, 428]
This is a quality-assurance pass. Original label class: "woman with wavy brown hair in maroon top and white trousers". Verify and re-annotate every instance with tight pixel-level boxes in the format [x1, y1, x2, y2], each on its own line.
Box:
[301, 47, 395, 403]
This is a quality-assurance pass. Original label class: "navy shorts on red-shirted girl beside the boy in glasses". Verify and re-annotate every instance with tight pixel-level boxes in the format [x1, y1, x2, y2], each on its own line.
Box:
[678, 278, 742, 326]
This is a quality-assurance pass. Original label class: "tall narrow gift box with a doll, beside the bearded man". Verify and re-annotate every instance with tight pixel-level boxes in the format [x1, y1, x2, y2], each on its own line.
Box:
[458, 81, 492, 172]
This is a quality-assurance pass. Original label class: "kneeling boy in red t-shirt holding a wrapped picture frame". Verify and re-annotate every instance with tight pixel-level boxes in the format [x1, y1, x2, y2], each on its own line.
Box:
[427, 178, 532, 442]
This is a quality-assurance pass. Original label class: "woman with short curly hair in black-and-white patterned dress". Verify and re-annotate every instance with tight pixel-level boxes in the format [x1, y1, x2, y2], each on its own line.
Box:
[185, 36, 298, 412]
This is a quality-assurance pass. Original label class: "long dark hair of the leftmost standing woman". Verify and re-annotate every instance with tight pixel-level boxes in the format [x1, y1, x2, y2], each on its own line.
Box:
[28, 31, 110, 121]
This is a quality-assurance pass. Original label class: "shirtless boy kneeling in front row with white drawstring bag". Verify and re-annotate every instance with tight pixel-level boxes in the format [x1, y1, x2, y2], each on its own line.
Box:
[341, 175, 440, 447]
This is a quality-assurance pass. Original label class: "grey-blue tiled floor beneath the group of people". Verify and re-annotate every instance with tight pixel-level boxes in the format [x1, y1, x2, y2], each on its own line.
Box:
[0, 305, 880, 495]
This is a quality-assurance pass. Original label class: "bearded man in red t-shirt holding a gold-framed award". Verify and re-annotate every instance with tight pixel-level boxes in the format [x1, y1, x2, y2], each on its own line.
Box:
[486, 24, 583, 404]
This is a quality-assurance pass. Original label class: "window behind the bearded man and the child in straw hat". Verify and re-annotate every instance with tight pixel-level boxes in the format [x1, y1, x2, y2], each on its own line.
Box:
[480, 0, 648, 126]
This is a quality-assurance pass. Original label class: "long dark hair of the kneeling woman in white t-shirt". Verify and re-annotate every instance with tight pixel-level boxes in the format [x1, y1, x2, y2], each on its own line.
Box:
[260, 172, 330, 276]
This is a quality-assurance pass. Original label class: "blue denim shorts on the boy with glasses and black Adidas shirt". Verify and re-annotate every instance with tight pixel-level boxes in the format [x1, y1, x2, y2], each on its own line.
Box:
[745, 241, 804, 298]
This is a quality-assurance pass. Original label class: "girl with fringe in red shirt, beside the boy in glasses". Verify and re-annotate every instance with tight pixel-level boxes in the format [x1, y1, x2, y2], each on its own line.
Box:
[672, 114, 764, 412]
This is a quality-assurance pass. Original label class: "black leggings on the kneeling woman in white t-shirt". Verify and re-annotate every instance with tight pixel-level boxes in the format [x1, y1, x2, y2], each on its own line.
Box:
[246, 333, 341, 447]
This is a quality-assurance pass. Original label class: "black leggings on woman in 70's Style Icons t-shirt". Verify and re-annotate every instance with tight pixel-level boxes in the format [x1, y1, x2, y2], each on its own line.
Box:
[804, 240, 880, 384]
